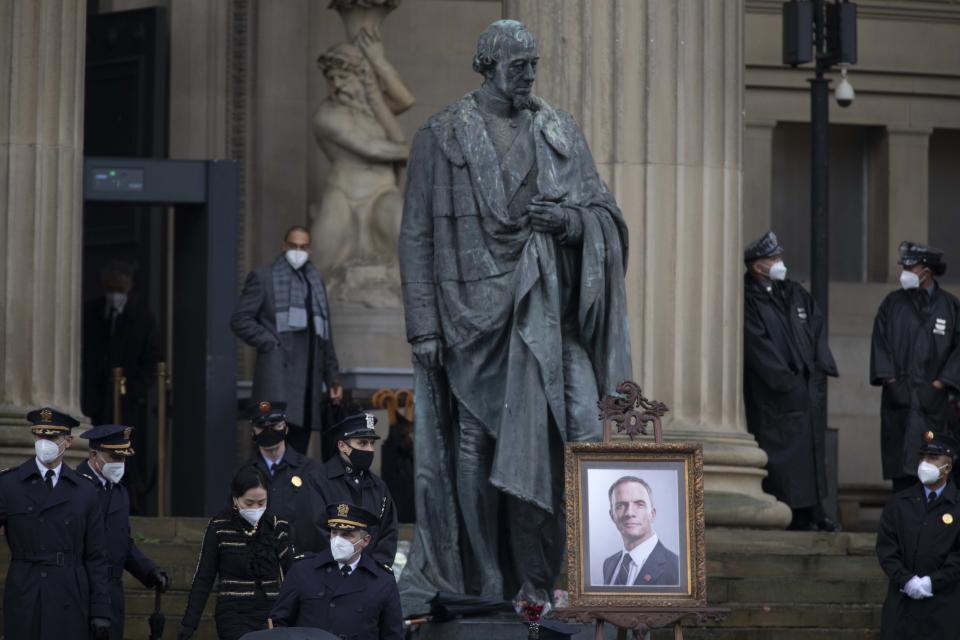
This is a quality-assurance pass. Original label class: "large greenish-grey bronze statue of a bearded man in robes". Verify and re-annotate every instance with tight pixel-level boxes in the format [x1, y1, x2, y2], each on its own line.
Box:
[399, 20, 631, 614]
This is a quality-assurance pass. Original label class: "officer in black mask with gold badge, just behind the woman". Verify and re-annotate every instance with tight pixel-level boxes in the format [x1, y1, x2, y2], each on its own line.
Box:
[241, 400, 318, 550]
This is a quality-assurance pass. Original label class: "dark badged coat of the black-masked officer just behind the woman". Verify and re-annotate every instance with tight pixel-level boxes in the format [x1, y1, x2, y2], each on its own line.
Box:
[244, 444, 318, 553]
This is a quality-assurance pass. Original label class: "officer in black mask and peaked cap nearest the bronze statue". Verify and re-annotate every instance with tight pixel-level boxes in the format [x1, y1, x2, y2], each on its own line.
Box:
[297, 413, 398, 567]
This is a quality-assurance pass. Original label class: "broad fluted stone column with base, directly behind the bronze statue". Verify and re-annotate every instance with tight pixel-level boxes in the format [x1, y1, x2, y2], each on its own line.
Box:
[504, 0, 790, 527]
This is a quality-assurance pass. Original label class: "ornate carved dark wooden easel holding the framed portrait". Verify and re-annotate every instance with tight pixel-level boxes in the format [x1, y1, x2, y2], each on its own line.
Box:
[554, 380, 730, 640]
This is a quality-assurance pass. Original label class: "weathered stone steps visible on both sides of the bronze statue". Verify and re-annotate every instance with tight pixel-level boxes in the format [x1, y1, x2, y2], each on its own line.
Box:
[0, 518, 886, 640]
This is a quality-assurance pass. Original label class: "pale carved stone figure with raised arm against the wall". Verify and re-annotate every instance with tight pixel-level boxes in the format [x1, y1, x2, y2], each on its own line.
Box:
[310, 0, 414, 306]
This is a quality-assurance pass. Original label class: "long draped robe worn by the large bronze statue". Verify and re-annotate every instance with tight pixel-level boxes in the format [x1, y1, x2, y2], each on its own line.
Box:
[400, 95, 631, 614]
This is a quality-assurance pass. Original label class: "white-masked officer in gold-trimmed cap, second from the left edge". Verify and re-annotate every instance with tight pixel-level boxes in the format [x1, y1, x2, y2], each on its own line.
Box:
[77, 424, 170, 640]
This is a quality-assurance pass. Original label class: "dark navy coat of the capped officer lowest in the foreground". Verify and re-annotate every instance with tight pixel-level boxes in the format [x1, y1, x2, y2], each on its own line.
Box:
[270, 550, 403, 640]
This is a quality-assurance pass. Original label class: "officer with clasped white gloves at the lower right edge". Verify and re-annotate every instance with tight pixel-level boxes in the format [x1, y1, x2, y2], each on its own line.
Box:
[877, 431, 960, 640]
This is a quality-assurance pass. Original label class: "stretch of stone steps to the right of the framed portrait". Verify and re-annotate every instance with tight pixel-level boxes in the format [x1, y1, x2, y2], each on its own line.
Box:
[696, 529, 887, 640]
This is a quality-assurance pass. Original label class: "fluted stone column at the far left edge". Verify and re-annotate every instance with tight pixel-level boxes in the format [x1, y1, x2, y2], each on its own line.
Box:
[0, 0, 86, 466]
